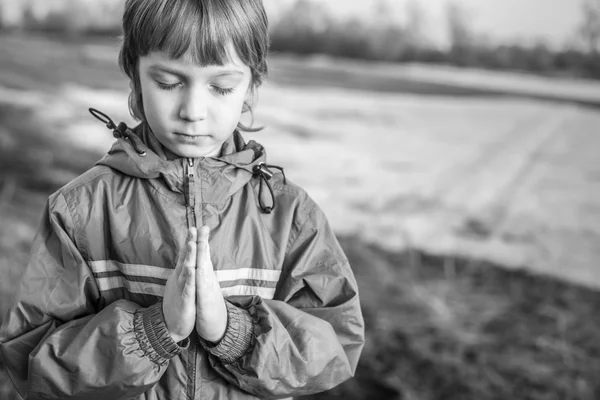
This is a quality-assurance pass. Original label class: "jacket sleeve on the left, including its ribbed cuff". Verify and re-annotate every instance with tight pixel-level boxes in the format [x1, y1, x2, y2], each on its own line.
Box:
[0, 192, 185, 399]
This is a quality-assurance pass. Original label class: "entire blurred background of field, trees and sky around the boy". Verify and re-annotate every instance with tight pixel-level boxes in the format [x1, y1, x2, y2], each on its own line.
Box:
[0, 0, 600, 400]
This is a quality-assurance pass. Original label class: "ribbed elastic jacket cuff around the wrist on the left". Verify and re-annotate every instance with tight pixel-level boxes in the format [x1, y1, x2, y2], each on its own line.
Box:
[133, 301, 189, 365]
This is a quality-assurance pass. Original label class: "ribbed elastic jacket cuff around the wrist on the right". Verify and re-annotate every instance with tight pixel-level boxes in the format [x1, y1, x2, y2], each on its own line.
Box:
[202, 301, 254, 364]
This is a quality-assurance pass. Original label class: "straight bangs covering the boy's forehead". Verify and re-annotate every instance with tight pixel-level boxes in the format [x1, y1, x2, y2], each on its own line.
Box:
[124, 0, 256, 66]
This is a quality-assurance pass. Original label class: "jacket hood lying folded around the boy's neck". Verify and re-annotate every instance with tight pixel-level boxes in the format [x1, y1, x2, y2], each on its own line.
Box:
[96, 123, 266, 203]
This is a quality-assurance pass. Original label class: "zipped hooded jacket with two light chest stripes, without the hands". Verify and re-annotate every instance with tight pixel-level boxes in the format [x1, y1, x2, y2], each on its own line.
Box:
[0, 124, 364, 400]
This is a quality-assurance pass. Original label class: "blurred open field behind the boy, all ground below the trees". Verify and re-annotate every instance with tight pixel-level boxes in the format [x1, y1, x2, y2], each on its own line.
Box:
[0, 37, 600, 400]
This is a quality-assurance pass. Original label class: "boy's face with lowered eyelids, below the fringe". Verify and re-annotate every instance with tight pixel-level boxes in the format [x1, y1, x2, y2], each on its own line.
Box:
[138, 46, 252, 158]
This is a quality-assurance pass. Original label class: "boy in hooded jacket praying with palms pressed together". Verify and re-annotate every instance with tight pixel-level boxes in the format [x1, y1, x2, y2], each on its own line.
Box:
[0, 0, 364, 399]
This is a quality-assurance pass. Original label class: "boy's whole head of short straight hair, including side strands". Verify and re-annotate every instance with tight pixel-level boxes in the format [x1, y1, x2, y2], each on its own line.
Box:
[119, 0, 269, 131]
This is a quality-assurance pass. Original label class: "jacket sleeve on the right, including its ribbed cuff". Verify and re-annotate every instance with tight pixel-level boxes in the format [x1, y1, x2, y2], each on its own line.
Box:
[205, 201, 364, 398]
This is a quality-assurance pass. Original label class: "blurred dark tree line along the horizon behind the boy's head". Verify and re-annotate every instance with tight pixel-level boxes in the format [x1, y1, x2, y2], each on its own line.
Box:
[0, 0, 600, 79]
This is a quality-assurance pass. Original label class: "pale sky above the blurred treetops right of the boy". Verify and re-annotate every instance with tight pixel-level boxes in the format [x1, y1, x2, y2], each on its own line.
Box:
[265, 0, 583, 46]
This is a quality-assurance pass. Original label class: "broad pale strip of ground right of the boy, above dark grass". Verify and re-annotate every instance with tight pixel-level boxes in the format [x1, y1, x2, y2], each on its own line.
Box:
[258, 87, 600, 287]
